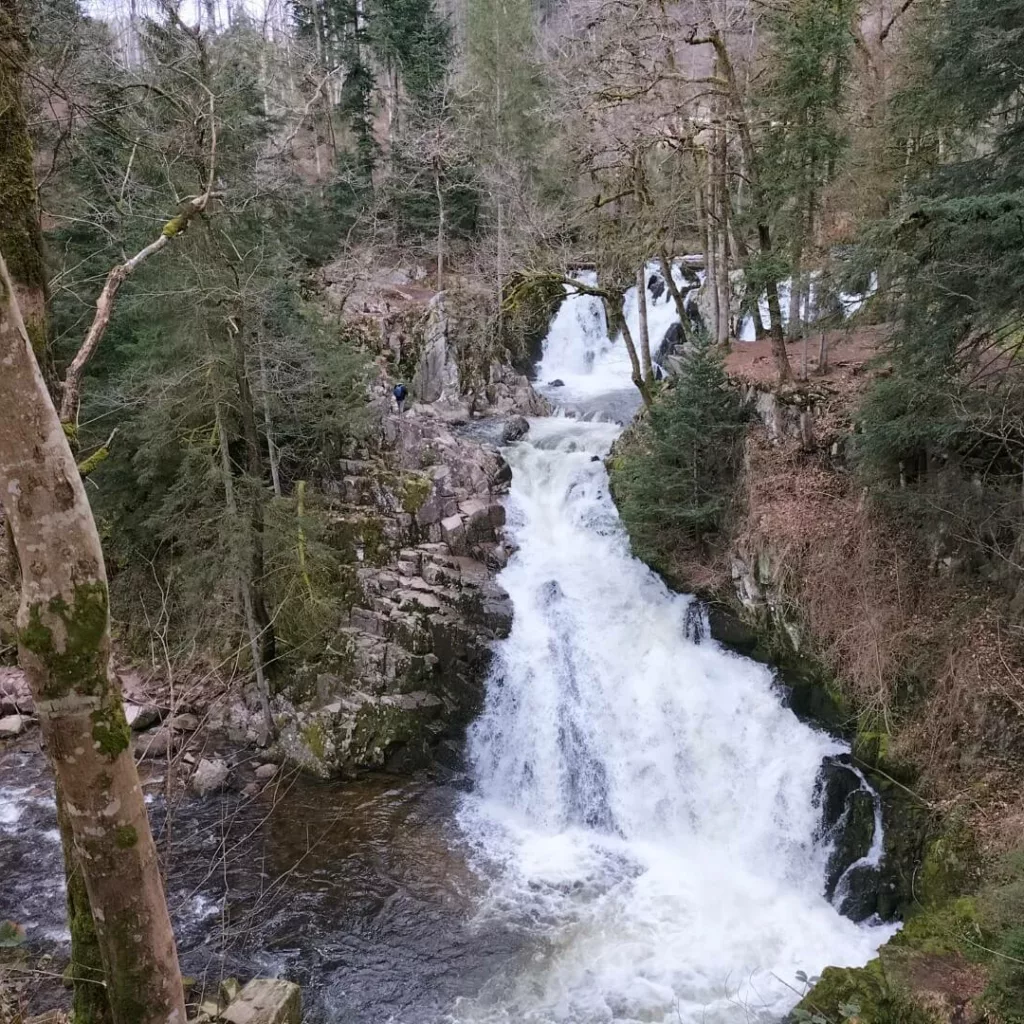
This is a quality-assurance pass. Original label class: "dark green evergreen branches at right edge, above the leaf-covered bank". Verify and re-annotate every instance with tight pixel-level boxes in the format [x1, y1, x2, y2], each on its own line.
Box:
[857, 0, 1024, 571]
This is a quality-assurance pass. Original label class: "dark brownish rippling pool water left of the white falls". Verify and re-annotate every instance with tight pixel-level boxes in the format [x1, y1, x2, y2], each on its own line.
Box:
[0, 743, 522, 1024]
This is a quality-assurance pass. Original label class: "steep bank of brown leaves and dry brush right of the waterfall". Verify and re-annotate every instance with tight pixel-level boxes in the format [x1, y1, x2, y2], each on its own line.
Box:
[616, 331, 1024, 1021]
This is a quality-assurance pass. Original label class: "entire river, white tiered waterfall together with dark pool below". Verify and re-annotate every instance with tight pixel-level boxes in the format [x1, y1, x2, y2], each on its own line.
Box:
[0, 270, 892, 1024]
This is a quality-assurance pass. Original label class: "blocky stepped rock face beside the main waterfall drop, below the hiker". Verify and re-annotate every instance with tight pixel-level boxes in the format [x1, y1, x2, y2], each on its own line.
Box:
[273, 407, 512, 777]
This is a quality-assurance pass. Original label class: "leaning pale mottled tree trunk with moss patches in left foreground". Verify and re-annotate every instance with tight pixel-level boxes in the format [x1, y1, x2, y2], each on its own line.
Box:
[0, 249, 185, 1024]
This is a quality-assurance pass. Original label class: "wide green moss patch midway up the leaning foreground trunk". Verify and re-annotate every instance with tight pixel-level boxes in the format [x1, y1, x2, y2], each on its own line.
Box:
[18, 581, 110, 700]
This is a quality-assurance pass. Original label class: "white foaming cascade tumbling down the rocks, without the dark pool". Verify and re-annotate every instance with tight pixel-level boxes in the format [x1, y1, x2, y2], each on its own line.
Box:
[455, 276, 891, 1024]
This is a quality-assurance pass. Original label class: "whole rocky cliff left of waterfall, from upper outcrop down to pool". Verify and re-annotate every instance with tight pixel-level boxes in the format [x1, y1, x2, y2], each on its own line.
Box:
[214, 280, 547, 777]
